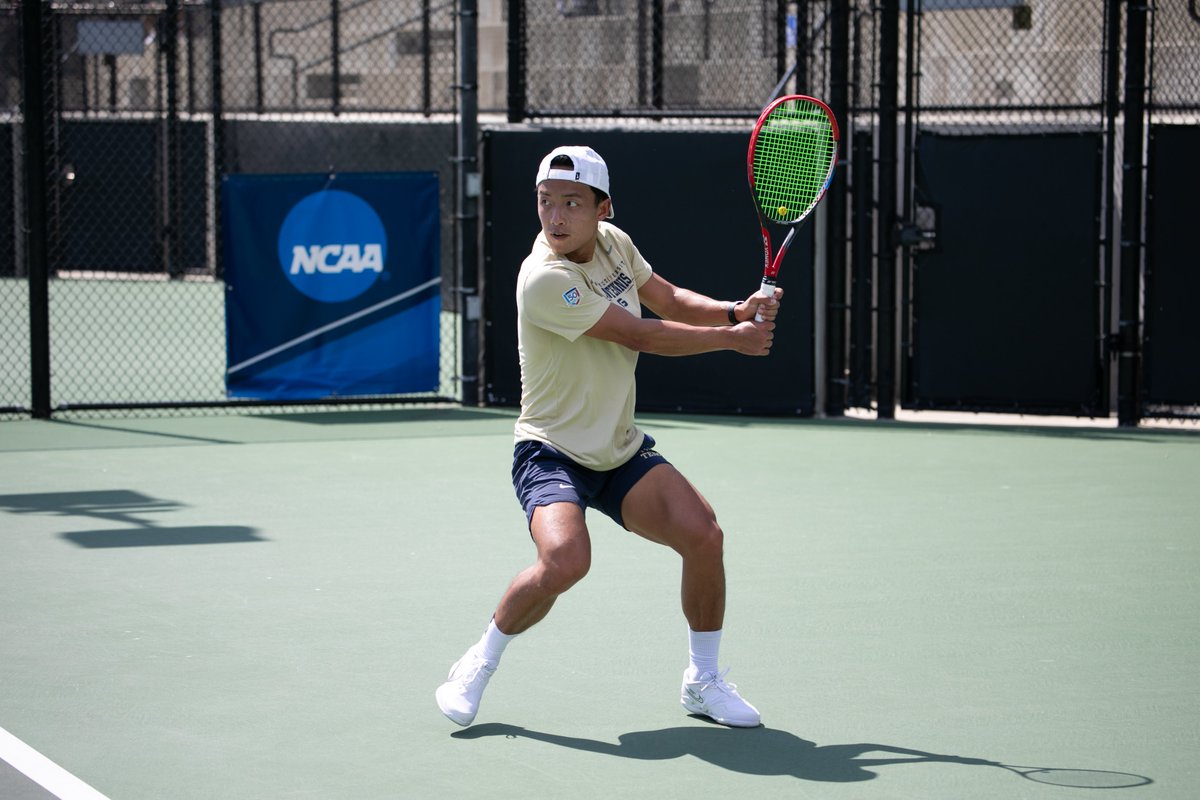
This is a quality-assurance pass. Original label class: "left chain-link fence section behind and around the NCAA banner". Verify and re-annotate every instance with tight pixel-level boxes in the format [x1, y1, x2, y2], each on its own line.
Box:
[0, 0, 462, 419]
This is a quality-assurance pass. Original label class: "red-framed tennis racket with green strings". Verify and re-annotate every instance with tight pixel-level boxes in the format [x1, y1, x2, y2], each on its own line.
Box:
[746, 95, 838, 321]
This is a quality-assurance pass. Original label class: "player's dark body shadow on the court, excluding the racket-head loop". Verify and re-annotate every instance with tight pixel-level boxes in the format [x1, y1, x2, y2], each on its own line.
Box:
[451, 723, 994, 783]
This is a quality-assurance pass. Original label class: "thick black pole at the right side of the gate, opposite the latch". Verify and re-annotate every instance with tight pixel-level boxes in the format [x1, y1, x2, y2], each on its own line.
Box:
[1117, 0, 1146, 426]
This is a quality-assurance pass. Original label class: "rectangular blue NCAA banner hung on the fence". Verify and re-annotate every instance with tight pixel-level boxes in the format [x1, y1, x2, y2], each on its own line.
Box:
[221, 173, 442, 399]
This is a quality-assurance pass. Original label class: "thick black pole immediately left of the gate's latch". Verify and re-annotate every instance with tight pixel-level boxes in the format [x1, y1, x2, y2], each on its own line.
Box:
[875, 0, 900, 420]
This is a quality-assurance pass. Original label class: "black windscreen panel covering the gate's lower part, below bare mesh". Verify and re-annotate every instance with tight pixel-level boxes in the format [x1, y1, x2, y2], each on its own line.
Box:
[904, 130, 1108, 416]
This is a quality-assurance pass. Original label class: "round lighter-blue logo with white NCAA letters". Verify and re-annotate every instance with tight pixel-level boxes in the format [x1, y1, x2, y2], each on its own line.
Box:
[280, 190, 388, 302]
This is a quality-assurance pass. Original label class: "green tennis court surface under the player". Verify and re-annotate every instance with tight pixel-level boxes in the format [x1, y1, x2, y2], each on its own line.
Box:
[0, 409, 1200, 800]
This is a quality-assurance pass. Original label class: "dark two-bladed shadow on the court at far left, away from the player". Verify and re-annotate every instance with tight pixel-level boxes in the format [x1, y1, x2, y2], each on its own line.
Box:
[0, 489, 266, 548]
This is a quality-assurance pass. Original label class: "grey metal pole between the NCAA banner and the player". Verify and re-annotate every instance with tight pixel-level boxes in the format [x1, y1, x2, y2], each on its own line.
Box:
[455, 0, 481, 405]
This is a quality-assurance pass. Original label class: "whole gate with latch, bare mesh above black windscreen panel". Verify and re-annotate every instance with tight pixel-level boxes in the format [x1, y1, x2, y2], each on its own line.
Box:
[899, 0, 1111, 416]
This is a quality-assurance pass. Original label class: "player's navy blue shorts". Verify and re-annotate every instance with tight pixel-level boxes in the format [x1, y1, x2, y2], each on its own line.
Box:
[512, 434, 667, 528]
